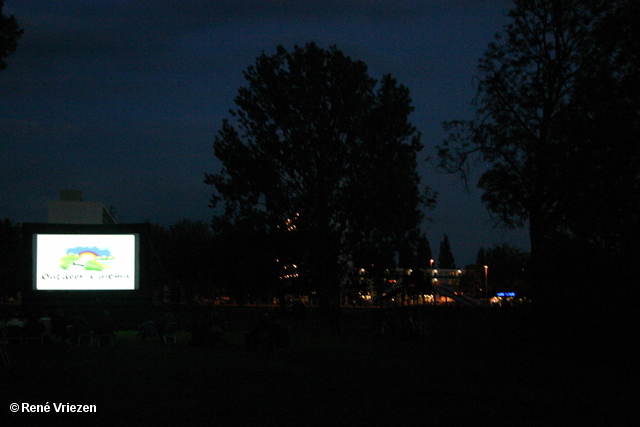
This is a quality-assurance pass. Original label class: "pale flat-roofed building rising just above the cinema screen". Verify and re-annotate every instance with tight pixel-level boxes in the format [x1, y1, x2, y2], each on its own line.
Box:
[48, 190, 116, 224]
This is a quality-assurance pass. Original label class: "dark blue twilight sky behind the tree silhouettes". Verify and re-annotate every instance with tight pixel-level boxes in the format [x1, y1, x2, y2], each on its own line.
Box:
[0, 0, 529, 267]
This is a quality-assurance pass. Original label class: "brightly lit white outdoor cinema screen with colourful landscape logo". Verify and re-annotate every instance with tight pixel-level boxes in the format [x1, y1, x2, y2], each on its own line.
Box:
[34, 234, 139, 290]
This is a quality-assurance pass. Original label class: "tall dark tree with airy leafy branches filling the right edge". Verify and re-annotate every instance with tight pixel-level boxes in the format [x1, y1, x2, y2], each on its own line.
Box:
[439, 0, 640, 308]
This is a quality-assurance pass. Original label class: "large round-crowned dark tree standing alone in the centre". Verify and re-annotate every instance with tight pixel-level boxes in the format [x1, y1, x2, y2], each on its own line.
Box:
[205, 43, 433, 304]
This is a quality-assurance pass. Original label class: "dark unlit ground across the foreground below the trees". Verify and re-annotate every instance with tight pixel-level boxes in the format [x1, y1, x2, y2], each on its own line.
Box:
[0, 307, 638, 426]
